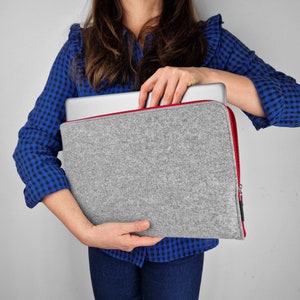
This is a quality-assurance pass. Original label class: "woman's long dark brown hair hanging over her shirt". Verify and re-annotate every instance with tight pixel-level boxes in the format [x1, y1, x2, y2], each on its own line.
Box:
[83, 0, 207, 89]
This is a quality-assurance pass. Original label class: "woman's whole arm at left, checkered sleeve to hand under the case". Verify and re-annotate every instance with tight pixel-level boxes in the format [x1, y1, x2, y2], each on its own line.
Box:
[14, 26, 161, 251]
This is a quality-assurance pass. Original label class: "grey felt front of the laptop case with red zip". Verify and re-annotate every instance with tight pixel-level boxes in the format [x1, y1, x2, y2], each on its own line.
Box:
[61, 101, 243, 239]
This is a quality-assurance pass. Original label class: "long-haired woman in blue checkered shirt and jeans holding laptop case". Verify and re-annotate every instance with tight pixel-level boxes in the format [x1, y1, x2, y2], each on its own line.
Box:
[14, 0, 300, 300]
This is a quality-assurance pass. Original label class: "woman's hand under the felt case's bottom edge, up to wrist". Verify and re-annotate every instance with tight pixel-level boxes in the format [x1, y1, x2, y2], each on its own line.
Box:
[83, 221, 162, 252]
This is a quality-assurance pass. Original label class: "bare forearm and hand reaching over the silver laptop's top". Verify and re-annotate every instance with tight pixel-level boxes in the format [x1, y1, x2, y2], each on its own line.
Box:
[139, 67, 265, 117]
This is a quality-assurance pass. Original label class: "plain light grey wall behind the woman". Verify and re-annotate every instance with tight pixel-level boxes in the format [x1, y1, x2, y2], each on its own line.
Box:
[0, 0, 300, 300]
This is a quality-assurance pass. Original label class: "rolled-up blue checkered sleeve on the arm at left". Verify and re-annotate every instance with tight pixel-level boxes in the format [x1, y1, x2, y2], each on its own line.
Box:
[13, 36, 77, 208]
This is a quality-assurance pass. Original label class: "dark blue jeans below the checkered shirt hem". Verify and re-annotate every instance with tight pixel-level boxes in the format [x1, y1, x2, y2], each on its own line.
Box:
[89, 248, 204, 300]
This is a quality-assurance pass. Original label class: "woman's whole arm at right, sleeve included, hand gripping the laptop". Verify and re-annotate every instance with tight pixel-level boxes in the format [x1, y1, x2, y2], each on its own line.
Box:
[140, 16, 300, 129]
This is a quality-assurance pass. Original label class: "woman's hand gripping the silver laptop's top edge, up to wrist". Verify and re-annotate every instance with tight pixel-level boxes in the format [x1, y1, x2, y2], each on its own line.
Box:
[139, 67, 206, 108]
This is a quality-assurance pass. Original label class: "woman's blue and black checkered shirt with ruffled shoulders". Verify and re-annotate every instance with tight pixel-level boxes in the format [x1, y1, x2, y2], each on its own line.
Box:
[14, 15, 300, 266]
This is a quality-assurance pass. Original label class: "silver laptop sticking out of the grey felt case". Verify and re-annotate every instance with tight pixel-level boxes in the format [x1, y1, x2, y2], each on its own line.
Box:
[65, 83, 226, 121]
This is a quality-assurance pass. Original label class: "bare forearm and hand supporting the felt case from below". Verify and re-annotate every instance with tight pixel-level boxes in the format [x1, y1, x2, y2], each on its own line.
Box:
[43, 189, 162, 251]
